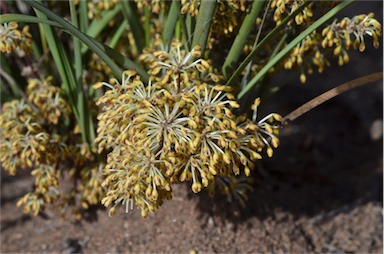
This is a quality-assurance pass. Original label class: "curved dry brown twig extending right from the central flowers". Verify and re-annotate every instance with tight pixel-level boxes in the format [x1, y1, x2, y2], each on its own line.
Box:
[282, 72, 383, 125]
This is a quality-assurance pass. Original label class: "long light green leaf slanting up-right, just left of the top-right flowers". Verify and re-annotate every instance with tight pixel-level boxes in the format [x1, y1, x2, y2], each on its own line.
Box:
[237, 1, 353, 99]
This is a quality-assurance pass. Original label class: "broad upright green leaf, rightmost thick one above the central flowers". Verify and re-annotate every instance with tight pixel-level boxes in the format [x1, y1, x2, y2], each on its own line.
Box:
[222, 0, 265, 78]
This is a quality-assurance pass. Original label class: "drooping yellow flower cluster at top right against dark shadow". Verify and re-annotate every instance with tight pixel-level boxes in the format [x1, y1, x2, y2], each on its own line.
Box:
[284, 13, 381, 83]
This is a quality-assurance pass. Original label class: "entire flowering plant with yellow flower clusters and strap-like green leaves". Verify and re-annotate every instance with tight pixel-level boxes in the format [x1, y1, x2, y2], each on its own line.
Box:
[0, 0, 381, 217]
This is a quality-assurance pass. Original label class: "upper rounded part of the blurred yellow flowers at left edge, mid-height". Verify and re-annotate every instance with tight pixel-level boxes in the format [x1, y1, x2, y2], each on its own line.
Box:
[0, 78, 69, 175]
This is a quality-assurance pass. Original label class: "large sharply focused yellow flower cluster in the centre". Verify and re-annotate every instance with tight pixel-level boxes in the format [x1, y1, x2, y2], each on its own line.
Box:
[95, 42, 281, 217]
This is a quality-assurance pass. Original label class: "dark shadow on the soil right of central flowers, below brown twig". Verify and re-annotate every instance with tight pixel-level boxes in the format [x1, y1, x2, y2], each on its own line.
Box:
[191, 79, 383, 224]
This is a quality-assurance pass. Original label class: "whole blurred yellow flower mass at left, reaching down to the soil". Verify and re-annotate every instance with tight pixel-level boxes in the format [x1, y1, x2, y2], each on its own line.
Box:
[0, 77, 103, 215]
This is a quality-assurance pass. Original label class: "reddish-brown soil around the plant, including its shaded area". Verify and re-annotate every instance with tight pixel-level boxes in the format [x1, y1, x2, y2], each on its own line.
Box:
[0, 1, 383, 253]
